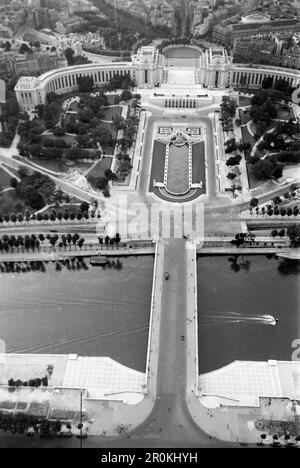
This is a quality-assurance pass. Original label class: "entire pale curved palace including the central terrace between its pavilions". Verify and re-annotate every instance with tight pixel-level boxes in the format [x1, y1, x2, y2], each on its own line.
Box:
[15, 46, 300, 112]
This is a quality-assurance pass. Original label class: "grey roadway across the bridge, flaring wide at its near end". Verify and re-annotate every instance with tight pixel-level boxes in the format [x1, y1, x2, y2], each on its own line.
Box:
[124, 239, 226, 447]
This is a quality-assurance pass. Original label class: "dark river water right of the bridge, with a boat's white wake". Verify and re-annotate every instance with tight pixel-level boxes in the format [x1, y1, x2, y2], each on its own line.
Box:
[197, 256, 300, 373]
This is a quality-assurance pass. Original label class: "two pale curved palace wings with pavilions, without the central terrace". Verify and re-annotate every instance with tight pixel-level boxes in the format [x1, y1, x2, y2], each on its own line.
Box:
[15, 47, 300, 112]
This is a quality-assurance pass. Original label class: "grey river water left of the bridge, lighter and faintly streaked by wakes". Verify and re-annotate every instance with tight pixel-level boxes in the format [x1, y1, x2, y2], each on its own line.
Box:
[0, 257, 154, 371]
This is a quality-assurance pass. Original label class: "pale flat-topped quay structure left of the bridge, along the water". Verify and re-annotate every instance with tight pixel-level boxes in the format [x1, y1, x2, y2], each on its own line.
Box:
[0, 354, 146, 402]
